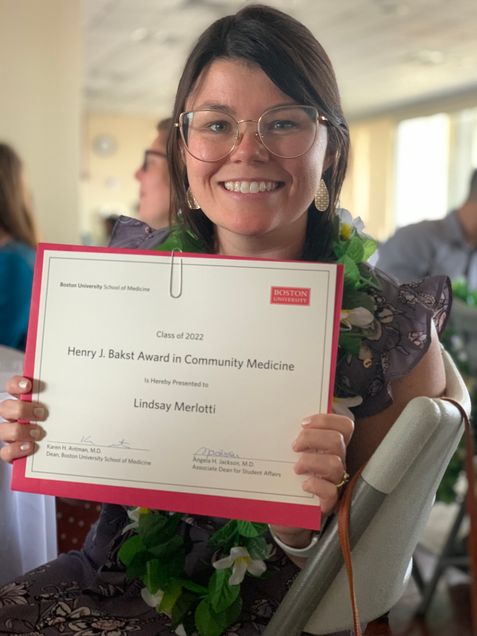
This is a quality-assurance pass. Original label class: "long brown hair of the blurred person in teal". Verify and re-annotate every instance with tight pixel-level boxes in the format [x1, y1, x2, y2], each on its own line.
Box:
[0, 143, 38, 247]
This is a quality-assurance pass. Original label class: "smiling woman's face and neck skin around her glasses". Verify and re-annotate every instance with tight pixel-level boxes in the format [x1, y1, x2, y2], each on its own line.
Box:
[183, 59, 327, 253]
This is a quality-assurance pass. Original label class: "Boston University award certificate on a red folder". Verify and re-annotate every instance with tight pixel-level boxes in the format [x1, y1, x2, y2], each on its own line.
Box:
[12, 244, 342, 529]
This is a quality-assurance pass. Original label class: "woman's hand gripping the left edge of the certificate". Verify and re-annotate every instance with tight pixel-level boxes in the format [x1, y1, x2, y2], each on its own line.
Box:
[0, 375, 48, 462]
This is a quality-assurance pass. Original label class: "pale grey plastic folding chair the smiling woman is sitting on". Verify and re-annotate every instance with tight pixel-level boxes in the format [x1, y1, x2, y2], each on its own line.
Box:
[265, 352, 470, 636]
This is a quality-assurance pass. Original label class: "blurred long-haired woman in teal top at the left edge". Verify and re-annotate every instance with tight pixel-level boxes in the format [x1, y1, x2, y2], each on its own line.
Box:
[0, 143, 37, 350]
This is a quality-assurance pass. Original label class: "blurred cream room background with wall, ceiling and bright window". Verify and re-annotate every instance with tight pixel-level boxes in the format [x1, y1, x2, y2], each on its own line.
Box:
[0, 0, 477, 243]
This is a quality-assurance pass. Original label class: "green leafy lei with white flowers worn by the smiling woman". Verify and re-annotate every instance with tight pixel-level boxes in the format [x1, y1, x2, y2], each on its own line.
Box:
[118, 210, 376, 636]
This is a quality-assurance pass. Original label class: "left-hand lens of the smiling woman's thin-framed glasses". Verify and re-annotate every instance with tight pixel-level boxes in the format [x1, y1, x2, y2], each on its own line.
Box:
[180, 110, 237, 161]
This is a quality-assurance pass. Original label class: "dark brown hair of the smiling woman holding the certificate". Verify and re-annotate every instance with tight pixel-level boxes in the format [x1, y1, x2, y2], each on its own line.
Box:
[168, 5, 349, 257]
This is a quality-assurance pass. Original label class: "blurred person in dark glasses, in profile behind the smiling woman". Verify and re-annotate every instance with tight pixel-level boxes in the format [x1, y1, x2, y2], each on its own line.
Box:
[134, 117, 172, 229]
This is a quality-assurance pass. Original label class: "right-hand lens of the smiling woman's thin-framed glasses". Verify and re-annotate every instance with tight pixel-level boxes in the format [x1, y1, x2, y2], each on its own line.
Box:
[258, 106, 318, 159]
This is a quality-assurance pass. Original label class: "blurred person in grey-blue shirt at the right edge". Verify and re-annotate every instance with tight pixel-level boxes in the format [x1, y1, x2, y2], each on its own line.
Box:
[377, 170, 477, 290]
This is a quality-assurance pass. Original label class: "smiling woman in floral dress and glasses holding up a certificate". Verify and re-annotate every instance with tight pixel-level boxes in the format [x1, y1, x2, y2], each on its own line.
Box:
[0, 6, 447, 636]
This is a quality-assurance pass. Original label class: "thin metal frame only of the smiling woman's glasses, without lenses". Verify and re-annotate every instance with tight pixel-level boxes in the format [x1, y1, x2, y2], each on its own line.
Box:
[174, 104, 329, 163]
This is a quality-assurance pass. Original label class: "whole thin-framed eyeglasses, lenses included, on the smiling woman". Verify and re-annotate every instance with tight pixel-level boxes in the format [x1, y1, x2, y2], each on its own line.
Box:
[175, 104, 328, 162]
